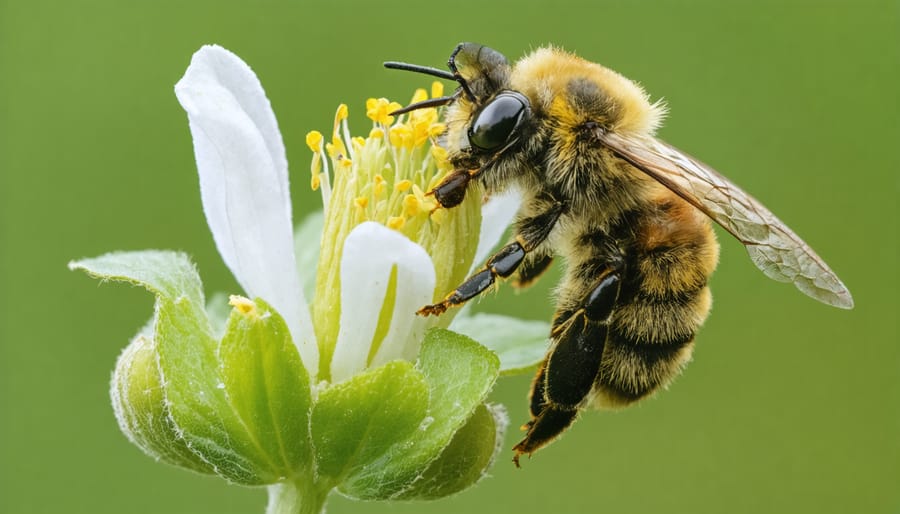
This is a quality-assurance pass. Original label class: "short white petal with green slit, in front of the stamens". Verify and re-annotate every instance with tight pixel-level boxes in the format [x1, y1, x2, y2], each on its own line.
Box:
[331, 221, 435, 382]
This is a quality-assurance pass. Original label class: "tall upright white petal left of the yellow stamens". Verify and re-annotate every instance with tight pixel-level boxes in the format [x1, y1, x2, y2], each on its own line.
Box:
[175, 46, 318, 374]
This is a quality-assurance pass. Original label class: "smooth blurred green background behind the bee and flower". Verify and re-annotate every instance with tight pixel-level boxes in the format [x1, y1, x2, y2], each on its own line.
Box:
[0, 0, 900, 514]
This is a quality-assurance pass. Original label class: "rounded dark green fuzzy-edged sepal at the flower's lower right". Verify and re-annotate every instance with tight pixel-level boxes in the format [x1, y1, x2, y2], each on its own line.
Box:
[396, 404, 508, 500]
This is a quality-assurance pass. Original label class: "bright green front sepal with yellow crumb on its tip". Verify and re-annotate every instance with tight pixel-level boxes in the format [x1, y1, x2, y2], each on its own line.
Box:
[218, 299, 312, 476]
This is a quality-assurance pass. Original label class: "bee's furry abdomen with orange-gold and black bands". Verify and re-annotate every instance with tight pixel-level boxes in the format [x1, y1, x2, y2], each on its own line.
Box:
[592, 199, 718, 408]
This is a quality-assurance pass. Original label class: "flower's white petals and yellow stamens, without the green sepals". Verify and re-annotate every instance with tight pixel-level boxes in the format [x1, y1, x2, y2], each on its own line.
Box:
[175, 46, 518, 383]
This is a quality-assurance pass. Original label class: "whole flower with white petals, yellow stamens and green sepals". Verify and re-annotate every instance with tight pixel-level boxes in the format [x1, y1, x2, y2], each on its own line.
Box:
[70, 46, 547, 512]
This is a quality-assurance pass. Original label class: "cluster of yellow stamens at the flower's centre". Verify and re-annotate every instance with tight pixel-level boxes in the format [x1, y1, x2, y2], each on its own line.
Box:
[306, 82, 481, 377]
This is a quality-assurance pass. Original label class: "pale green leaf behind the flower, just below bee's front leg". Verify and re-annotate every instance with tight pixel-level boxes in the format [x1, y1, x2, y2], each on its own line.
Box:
[450, 313, 550, 376]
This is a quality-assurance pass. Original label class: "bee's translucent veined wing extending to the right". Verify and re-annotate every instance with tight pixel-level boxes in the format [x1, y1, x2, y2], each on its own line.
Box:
[601, 132, 853, 309]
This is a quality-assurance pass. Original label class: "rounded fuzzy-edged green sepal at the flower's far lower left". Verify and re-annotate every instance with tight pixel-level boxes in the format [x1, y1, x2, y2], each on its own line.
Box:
[110, 334, 215, 474]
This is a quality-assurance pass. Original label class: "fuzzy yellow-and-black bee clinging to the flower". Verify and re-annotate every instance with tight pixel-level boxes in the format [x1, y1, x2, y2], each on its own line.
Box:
[385, 43, 853, 466]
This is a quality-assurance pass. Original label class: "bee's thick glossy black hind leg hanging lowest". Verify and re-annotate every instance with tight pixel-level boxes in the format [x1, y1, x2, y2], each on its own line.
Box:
[513, 267, 621, 465]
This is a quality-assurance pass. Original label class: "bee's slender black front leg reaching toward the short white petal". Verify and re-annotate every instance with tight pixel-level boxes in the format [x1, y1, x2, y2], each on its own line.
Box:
[416, 200, 563, 316]
